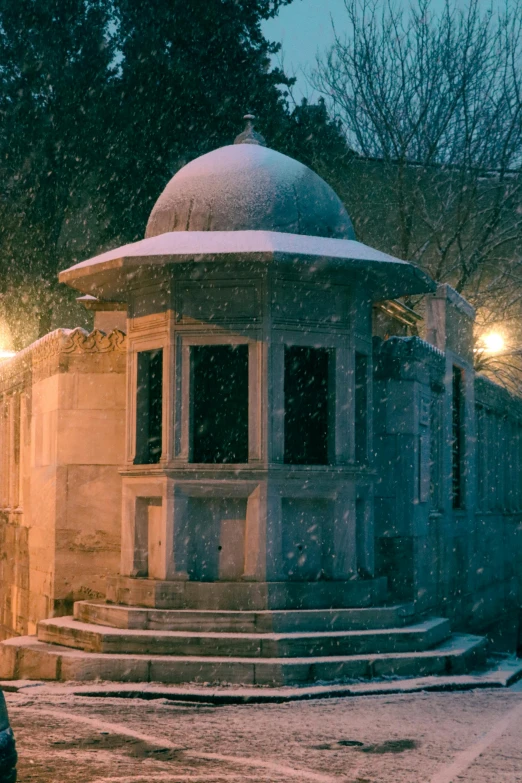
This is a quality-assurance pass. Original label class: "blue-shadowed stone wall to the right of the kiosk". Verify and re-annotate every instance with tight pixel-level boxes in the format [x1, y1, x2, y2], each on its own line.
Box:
[374, 337, 522, 644]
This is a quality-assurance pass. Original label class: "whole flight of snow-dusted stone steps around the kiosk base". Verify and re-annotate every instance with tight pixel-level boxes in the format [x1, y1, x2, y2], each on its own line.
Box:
[0, 580, 486, 686]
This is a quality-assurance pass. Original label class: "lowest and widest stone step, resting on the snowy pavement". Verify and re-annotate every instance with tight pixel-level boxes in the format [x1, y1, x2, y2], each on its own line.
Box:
[0, 634, 487, 686]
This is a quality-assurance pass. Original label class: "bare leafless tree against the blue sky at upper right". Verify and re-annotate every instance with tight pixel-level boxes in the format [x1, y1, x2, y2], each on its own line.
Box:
[310, 0, 522, 356]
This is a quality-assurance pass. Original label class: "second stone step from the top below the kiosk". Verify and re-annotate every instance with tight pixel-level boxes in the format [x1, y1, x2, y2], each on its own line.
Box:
[74, 601, 415, 633]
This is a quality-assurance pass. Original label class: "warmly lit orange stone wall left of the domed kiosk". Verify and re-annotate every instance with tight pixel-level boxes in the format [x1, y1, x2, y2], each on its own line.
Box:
[0, 329, 126, 638]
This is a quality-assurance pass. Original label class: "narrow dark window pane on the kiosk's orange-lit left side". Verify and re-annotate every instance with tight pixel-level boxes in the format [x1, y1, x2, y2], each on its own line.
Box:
[134, 349, 163, 465]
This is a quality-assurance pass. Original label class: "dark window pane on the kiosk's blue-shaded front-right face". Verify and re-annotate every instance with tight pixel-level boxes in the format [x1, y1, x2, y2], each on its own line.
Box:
[284, 346, 329, 465]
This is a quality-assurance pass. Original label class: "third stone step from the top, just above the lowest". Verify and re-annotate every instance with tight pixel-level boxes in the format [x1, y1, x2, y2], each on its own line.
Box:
[38, 617, 450, 658]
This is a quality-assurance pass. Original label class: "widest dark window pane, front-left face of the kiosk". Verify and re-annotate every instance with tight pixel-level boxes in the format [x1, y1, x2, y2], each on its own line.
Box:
[192, 345, 248, 464]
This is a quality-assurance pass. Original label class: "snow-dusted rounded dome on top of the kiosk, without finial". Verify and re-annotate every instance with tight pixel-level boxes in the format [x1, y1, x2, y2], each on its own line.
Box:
[145, 144, 355, 239]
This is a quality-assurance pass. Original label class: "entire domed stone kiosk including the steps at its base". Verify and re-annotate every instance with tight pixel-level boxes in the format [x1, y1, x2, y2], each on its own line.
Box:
[0, 122, 490, 684]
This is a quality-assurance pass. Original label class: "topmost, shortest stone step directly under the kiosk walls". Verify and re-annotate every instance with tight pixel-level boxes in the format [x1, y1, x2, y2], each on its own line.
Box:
[107, 576, 387, 611]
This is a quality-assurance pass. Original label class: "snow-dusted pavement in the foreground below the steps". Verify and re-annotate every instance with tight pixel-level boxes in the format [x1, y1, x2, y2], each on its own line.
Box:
[6, 683, 522, 783]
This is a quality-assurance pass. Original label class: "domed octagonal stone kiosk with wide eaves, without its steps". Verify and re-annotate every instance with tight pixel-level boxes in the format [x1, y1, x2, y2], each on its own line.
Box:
[60, 117, 433, 596]
